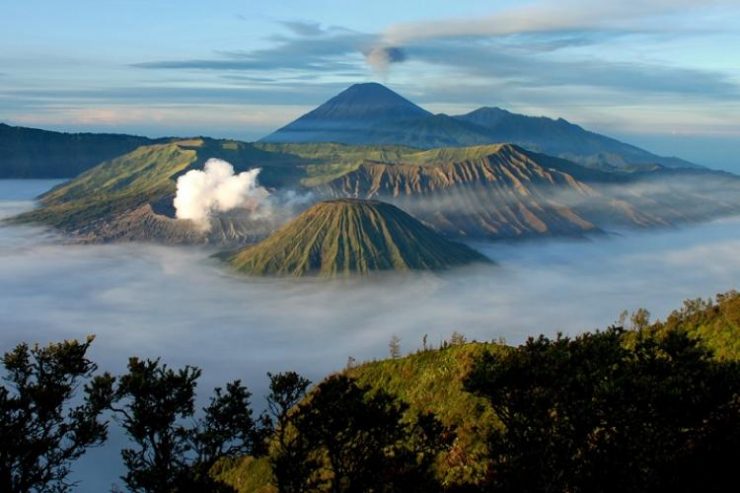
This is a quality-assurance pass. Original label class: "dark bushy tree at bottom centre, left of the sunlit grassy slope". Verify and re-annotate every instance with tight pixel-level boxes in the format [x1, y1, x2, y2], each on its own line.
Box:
[275, 375, 445, 493]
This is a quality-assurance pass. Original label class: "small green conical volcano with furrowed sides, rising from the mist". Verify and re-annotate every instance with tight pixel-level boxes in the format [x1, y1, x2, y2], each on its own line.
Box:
[226, 199, 489, 277]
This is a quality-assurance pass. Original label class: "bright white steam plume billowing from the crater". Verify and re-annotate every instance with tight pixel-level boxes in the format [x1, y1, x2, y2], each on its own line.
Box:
[173, 158, 270, 231]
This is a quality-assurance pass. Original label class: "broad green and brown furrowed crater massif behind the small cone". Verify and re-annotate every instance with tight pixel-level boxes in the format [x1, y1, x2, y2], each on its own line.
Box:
[15, 135, 740, 246]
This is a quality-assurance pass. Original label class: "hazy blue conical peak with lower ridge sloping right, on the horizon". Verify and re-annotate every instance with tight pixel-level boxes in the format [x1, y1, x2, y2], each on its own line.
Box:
[262, 83, 699, 170]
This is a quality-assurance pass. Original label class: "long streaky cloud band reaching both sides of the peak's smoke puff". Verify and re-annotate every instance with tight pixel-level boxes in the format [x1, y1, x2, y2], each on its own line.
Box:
[129, 0, 740, 103]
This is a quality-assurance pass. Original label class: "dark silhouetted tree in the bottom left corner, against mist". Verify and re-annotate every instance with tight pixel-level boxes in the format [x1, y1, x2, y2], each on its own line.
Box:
[0, 336, 113, 493]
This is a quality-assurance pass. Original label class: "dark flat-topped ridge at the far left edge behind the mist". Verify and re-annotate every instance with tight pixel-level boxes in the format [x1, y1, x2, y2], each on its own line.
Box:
[0, 123, 154, 179]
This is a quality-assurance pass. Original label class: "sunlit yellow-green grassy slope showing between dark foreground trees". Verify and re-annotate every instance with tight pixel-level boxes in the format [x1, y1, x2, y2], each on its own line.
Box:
[218, 292, 740, 493]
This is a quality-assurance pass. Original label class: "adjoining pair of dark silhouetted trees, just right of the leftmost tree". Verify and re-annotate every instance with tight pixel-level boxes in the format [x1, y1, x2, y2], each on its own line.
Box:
[114, 358, 255, 493]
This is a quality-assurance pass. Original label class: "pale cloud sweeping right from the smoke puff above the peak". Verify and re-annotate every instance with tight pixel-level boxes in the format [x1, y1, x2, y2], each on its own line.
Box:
[368, 0, 740, 95]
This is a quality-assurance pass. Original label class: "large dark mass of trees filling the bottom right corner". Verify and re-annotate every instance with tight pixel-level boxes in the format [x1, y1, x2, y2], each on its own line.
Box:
[466, 328, 740, 492]
